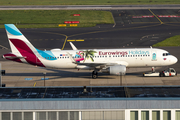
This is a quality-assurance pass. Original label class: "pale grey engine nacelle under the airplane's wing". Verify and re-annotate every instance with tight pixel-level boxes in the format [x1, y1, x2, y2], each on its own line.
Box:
[101, 65, 126, 75]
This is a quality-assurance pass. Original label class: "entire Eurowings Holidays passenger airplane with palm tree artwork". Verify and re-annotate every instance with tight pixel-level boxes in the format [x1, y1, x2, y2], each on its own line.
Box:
[3, 24, 178, 79]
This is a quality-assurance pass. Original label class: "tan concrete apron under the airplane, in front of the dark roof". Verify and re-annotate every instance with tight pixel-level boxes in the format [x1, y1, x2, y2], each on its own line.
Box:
[1, 61, 180, 87]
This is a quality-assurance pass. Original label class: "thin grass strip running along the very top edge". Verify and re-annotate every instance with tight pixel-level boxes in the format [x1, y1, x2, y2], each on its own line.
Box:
[0, 0, 180, 5]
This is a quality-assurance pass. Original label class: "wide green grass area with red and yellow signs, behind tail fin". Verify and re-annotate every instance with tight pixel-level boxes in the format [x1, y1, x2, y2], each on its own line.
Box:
[0, 10, 114, 28]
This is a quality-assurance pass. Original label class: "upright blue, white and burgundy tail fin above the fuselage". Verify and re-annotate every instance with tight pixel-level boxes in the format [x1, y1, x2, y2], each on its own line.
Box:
[5, 24, 36, 54]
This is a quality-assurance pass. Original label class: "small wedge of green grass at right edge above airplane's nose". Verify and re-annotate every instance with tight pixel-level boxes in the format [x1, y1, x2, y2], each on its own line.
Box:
[153, 35, 180, 47]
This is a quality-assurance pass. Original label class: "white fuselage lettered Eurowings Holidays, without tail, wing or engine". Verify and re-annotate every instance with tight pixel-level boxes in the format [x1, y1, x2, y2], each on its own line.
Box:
[35, 48, 177, 68]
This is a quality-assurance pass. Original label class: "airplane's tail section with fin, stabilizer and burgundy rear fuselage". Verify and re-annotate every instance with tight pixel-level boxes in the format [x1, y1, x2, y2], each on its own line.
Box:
[4, 24, 44, 67]
